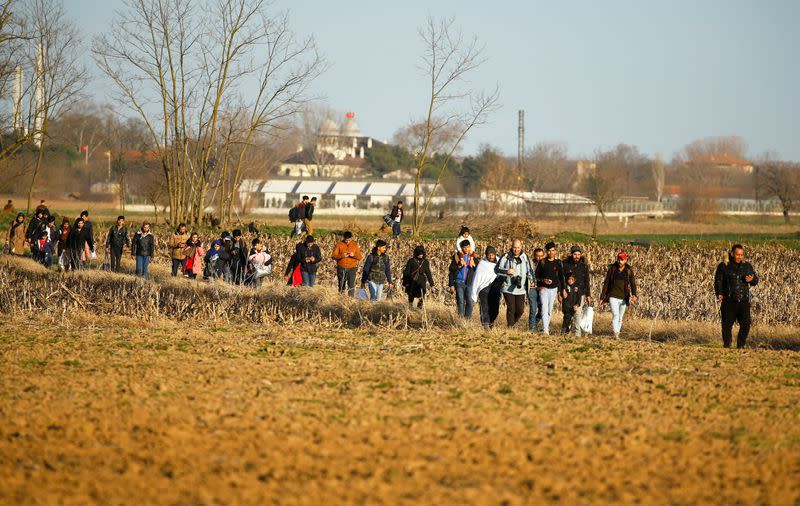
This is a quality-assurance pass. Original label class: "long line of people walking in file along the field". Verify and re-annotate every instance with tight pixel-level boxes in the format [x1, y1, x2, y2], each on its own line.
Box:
[7, 202, 758, 348]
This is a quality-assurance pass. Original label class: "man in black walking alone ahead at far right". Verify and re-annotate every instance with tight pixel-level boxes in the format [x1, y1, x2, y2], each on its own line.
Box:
[714, 244, 758, 348]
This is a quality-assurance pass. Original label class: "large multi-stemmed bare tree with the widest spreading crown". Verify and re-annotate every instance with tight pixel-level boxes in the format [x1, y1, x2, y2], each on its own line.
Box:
[93, 0, 324, 223]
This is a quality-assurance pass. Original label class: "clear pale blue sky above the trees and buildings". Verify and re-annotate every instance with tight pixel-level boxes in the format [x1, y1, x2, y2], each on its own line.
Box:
[72, 0, 800, 161]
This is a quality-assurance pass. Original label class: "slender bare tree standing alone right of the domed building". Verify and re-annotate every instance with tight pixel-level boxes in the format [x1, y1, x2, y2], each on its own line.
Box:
[413, 17, 499, 236]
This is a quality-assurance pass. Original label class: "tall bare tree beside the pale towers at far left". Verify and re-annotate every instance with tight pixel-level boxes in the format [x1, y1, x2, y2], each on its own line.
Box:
[27, 0, 87, 212]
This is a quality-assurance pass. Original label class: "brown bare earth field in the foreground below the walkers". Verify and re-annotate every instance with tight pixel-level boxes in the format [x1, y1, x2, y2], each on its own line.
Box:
[0, 310, 800, 505]
